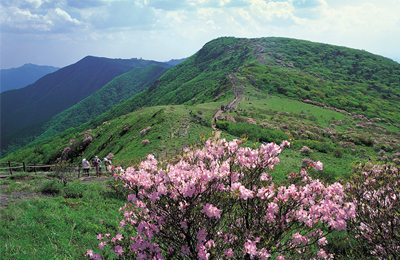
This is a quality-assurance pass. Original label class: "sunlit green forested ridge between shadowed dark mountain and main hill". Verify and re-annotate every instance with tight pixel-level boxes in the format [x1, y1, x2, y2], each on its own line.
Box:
[1, 64, 168, 156]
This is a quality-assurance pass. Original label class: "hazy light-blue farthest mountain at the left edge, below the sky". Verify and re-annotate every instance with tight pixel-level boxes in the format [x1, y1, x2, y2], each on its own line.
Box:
[0, 63, 59, 92]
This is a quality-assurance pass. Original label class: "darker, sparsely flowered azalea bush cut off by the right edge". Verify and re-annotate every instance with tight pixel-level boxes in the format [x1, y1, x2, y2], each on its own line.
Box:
[346, 162, 400, 259]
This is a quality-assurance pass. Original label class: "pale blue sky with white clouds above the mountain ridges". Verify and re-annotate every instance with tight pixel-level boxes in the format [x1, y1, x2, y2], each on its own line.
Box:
[0, 0, 400, 69]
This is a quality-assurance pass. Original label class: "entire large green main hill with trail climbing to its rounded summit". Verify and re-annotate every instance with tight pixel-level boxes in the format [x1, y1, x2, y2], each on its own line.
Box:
[1, 37, 400, 167]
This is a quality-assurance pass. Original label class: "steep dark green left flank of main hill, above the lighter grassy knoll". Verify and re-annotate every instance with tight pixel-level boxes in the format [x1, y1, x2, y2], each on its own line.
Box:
[76, 37, 256, 127]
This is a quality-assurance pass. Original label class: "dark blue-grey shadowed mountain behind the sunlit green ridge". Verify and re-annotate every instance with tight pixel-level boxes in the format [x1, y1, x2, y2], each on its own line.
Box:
[0, 57, 170, 136]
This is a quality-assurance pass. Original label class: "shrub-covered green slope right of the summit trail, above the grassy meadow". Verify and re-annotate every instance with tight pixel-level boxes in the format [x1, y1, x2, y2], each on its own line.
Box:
[245, 38, 400, 123]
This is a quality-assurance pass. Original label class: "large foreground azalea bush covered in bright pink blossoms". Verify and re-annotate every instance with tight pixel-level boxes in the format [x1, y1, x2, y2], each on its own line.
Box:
[86, 140, 355, 259]
